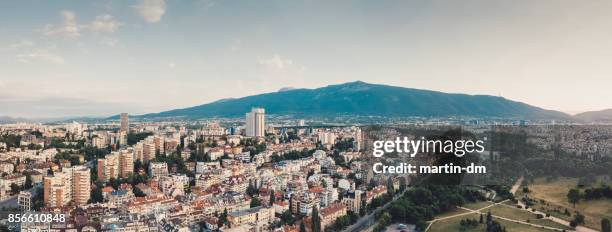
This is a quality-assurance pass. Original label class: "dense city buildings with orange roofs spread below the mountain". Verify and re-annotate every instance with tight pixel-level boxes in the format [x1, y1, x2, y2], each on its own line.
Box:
[0, 108, 612, 231]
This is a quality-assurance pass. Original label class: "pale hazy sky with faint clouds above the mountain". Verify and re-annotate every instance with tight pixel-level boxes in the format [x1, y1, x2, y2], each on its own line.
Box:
[0, 0, 612, 118]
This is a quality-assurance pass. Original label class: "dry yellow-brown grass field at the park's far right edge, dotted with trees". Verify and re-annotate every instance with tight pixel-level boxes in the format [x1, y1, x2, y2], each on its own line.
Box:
[528, 178, 612, 229]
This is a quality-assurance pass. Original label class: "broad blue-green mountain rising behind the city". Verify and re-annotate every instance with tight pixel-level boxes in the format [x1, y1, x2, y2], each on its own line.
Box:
[134, 81, 570, 119]
